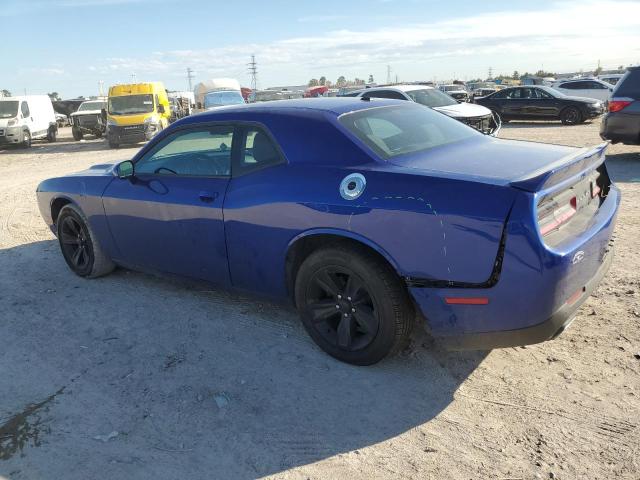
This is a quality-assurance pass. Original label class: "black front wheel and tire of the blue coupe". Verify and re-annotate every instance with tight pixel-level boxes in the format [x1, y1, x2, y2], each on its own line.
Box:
[56, 204, 115, 278]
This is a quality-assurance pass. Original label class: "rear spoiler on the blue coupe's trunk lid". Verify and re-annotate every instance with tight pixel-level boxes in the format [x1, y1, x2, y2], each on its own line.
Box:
[510, 142, 609, 192]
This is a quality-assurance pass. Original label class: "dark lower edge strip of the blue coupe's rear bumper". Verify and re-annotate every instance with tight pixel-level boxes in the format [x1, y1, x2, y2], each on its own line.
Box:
[439, 249, 613, 350]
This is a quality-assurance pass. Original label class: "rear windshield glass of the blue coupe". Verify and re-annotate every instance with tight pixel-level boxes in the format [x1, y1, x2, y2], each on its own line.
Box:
[339, 102, 482, 160]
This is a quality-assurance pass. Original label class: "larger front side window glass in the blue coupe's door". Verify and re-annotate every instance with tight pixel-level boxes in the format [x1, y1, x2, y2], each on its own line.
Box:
[136, 126, 234, 177]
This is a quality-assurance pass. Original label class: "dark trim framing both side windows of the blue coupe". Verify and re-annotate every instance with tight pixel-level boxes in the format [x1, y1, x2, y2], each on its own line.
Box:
[132, 120, 290, 180]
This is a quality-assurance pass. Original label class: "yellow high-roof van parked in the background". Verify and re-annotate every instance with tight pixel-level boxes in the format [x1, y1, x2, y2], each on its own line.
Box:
[106, 82, 171, 148]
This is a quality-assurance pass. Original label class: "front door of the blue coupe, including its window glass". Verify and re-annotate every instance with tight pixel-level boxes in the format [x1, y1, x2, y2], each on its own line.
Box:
[103, 125, 235, 285]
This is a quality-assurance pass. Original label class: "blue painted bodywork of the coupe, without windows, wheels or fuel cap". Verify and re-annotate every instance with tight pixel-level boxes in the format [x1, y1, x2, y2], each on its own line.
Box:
[37, 98, 620, 348]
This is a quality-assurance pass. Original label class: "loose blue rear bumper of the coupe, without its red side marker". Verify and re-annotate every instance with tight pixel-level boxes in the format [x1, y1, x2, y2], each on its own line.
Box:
[409, 185, 620, 349]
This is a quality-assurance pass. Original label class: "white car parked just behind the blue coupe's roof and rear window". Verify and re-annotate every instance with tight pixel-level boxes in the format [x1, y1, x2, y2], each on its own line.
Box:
[348, 85, 501, 135]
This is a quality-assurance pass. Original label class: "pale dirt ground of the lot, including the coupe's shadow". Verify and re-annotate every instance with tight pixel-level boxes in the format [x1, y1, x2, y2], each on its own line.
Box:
[0, 122, 640, 480]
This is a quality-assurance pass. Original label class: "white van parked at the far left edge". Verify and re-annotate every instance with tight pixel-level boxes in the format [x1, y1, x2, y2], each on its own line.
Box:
[0, 95, 58, 148]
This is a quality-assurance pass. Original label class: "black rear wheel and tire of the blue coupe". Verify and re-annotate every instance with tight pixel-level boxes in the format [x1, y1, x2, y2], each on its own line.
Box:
[295, 244, 415, 365]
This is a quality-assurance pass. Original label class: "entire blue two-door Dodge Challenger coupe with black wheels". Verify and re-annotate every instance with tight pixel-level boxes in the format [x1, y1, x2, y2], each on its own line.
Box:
[37, 98, 620, 365]
